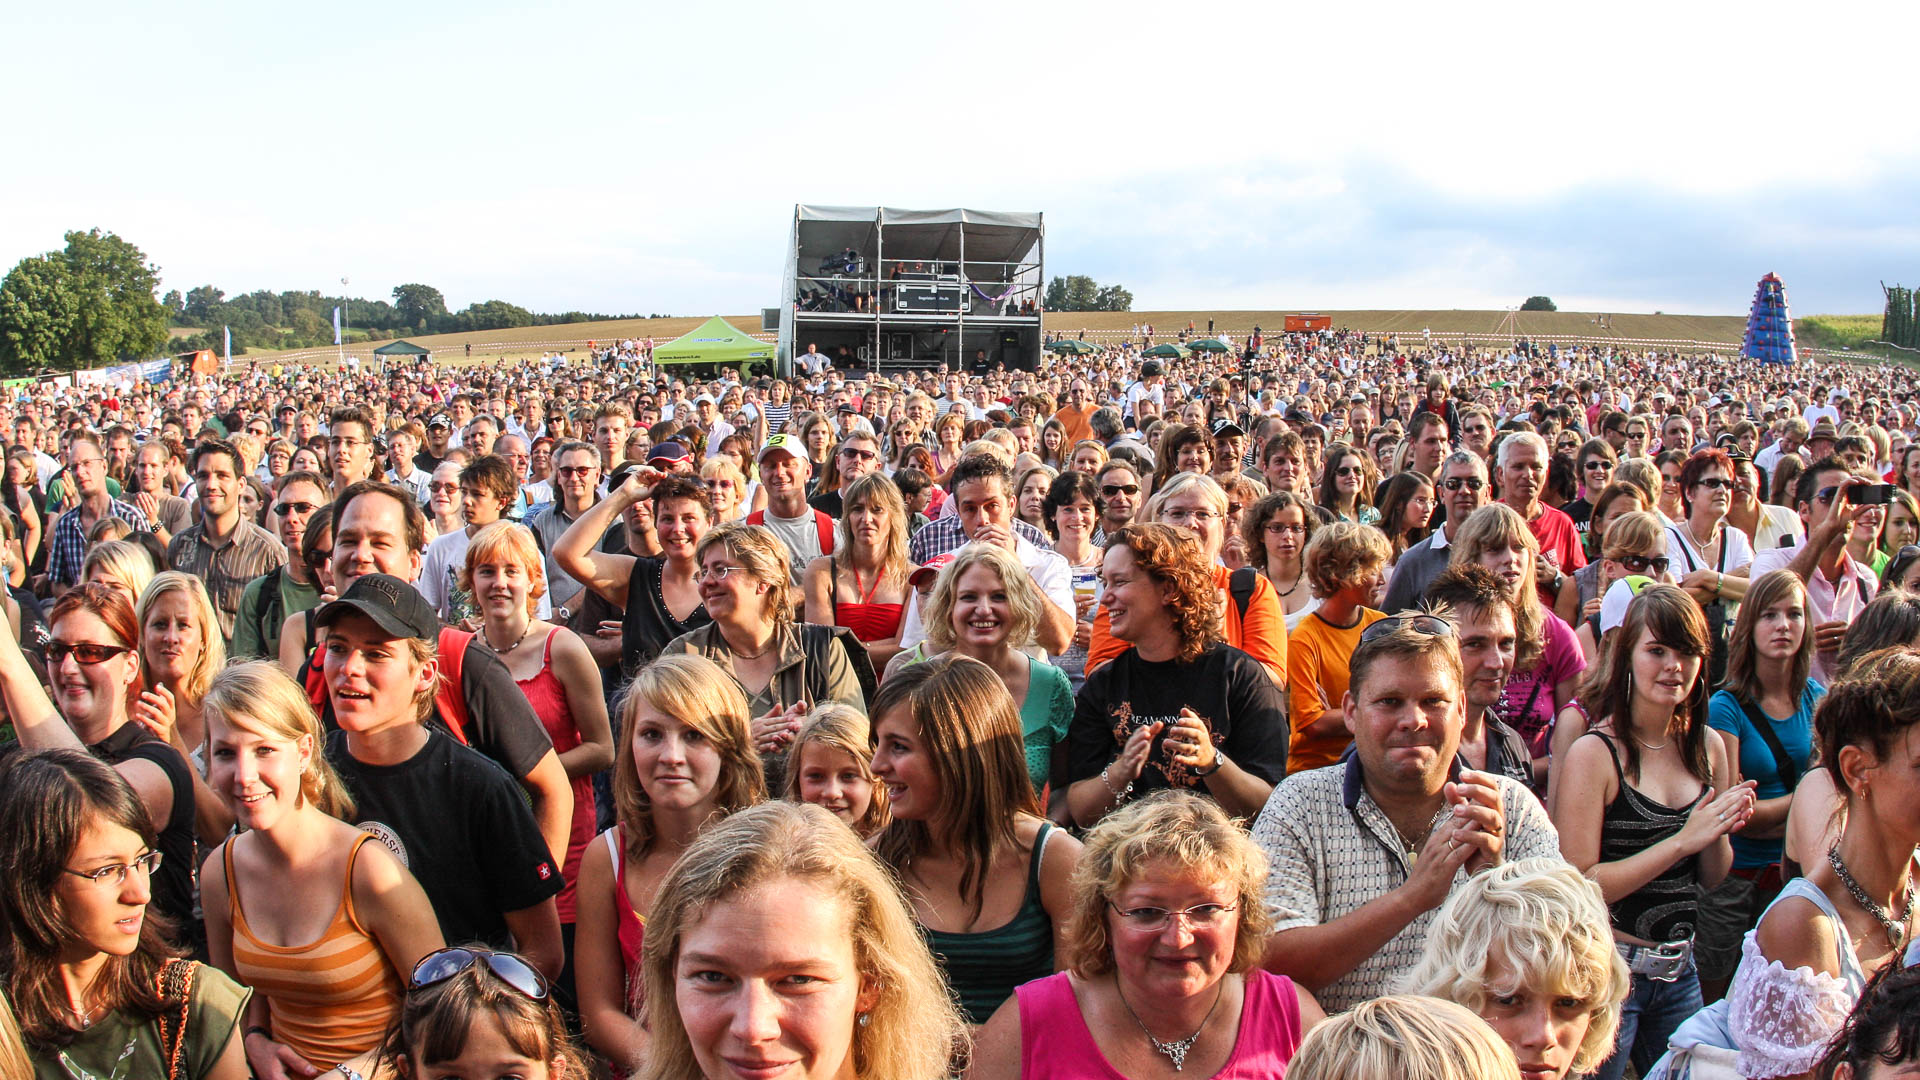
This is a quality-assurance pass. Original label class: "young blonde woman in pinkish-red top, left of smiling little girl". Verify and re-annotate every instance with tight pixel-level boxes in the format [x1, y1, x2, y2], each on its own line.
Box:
[574, 655, 766, 1070]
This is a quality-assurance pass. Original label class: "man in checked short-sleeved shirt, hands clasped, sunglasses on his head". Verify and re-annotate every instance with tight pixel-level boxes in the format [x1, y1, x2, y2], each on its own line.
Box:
[1254, 611, 1559, 1011]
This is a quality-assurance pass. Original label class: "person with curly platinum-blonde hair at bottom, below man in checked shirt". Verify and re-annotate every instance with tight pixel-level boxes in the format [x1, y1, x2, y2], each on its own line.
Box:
[1400, 859, 1630, 1080]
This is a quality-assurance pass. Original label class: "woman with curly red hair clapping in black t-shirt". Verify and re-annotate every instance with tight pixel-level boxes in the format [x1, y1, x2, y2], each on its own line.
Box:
[1068, 525, 1288, 826]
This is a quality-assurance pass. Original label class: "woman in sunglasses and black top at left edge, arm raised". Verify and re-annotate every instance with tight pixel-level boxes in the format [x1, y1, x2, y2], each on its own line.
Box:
[0, 584, 205, 945]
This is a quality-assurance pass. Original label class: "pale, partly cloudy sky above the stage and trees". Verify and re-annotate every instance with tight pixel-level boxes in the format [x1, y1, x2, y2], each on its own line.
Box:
[0, 0, 1920, 315]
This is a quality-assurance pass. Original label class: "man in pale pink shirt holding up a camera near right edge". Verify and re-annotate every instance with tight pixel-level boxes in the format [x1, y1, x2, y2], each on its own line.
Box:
[1730, 457, 1885, 684]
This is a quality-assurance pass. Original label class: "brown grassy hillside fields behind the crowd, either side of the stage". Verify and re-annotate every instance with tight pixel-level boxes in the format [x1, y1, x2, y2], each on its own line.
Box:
[220, 307, 1880, 363]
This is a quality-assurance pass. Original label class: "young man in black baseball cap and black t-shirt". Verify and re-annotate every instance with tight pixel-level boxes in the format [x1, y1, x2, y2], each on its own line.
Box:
[315, 575, 564, 978]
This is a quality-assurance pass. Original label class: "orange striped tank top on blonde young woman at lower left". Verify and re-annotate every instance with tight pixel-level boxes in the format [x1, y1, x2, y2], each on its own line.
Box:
[225, 834, 401, 1070]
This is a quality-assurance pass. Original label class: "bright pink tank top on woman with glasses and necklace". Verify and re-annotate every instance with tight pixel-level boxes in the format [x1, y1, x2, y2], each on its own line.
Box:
[1014, 969, 1300, 1080]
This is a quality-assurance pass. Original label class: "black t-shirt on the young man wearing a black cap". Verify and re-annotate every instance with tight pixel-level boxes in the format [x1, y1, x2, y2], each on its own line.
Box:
[326, 728, 564, 949]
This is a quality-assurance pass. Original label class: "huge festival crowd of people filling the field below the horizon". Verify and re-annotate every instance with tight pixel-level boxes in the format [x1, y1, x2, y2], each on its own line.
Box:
[0, 331, 1920, 1080]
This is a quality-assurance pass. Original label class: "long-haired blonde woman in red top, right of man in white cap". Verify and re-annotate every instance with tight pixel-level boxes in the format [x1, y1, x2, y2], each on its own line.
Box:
[803, 473, 914, 671]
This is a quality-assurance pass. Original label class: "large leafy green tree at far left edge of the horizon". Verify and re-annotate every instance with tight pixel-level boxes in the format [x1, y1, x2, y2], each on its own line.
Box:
[0, 229, 167, 369]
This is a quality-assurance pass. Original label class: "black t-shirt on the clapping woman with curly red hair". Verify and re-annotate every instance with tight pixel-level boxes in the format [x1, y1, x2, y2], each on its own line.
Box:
[1068, 644, 1290, 794]
